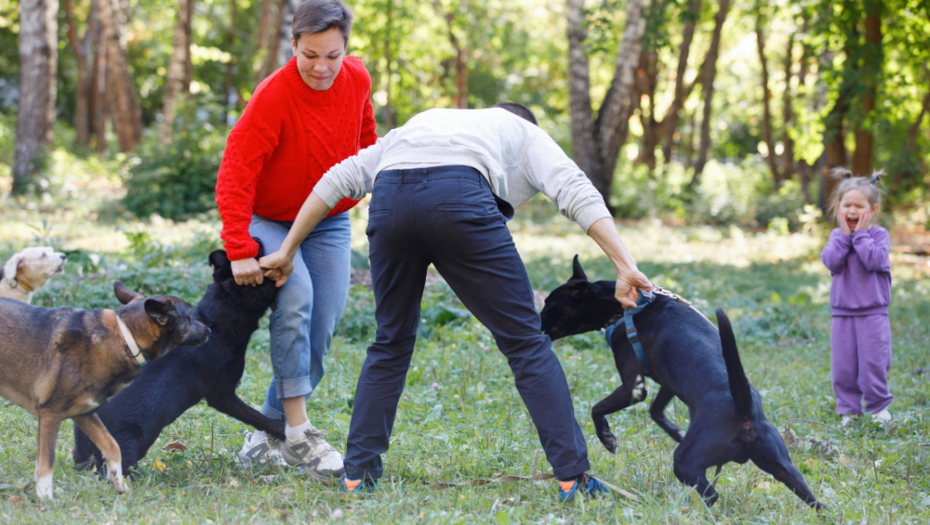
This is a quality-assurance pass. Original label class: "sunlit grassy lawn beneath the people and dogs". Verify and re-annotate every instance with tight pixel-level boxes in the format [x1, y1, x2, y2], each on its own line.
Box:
[0, 191, 930, 525]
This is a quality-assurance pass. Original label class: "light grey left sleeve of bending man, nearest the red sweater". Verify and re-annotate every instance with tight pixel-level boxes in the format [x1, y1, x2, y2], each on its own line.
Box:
[313, 131, 384, 208]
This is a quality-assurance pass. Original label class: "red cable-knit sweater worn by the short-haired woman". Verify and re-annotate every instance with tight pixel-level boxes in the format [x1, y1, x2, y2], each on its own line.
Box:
[216, 56, 378, 261]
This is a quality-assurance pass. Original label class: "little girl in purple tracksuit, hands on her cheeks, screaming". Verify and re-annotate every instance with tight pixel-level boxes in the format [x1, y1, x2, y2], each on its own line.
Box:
[820, 169, 894, 425]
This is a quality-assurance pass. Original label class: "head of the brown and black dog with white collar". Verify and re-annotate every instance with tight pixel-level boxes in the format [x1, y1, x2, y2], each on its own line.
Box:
[113, 281, 210, 359]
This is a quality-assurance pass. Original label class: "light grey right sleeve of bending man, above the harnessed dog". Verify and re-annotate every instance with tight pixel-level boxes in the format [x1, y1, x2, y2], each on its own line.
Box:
[525, 128, 611, 233]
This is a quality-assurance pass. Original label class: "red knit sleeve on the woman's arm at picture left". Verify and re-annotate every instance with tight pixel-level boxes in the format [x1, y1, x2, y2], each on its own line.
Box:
[216, 92, 280, 261]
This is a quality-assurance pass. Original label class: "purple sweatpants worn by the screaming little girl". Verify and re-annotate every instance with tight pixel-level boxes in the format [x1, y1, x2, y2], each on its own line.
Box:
[830, 315, 894, 415]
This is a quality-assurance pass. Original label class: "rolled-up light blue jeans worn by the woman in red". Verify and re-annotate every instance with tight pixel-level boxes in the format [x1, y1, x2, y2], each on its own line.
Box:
[249, 213, 352, 419]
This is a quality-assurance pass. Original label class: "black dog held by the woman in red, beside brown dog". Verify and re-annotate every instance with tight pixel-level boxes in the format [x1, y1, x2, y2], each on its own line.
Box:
[73, 246, 284, 472]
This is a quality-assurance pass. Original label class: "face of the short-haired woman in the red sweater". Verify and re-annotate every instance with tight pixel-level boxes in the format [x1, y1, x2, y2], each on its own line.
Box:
[291, 27, 348, 91]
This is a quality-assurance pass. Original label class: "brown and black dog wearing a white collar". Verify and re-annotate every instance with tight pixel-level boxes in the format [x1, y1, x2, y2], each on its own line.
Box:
[0, 281, 210, 498]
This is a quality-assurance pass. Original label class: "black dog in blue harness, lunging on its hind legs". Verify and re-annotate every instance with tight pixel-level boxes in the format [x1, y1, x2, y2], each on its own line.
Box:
[541, 255, 823, 509]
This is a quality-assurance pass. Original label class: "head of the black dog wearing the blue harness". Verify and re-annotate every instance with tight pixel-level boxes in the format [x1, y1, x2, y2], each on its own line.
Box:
[540, 255, 623, 341]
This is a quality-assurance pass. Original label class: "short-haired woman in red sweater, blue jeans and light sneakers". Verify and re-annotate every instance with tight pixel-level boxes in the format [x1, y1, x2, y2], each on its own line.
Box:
[216, 0, 378, 482]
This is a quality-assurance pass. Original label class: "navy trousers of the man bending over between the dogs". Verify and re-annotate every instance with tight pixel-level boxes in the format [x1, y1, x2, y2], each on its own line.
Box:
[345, 166, 590, 480]
